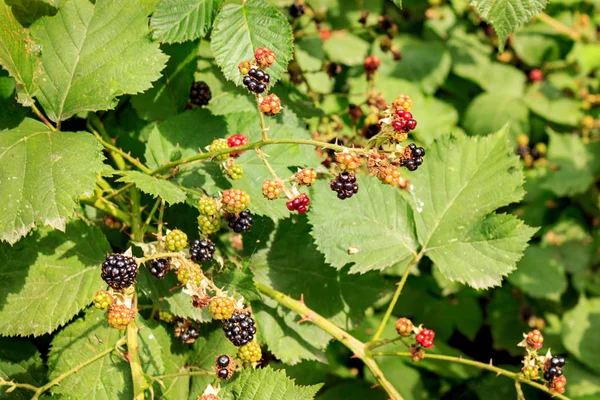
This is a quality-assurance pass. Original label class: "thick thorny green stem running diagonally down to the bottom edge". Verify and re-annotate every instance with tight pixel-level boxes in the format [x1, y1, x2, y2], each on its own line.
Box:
[254, 281, 403, 400]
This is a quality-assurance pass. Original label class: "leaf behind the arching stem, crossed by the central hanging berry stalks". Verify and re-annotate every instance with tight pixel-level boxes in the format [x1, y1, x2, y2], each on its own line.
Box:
[227, 110, 321, 220]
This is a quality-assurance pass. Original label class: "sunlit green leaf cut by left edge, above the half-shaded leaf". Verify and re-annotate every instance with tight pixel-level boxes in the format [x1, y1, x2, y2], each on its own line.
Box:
[0, 119, 103, 243]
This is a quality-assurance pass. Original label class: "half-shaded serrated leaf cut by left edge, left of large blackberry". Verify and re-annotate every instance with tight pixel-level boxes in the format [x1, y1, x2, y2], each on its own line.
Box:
[0, 220, 110, 336]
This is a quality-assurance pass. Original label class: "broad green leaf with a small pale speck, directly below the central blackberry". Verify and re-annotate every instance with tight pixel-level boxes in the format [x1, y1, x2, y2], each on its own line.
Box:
[309, 175, 418, 273]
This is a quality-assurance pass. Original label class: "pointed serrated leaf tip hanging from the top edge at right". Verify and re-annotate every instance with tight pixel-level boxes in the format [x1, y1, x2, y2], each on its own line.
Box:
[471, 0, 548, 51]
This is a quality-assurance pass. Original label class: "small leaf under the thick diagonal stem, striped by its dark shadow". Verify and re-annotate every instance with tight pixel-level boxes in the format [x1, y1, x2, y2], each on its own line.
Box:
[252, 299, 332, 365]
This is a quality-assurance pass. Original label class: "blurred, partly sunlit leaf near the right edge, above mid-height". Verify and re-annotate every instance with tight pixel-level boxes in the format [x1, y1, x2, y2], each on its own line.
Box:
[541, 130, 594, 197]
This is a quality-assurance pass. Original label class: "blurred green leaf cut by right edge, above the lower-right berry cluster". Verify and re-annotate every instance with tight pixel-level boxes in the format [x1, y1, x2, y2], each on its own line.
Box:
[562, 297, 600, 374]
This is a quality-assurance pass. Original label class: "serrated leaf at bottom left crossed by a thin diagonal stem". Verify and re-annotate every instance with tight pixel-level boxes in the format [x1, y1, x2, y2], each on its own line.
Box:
[48, 310, 133, 400]
